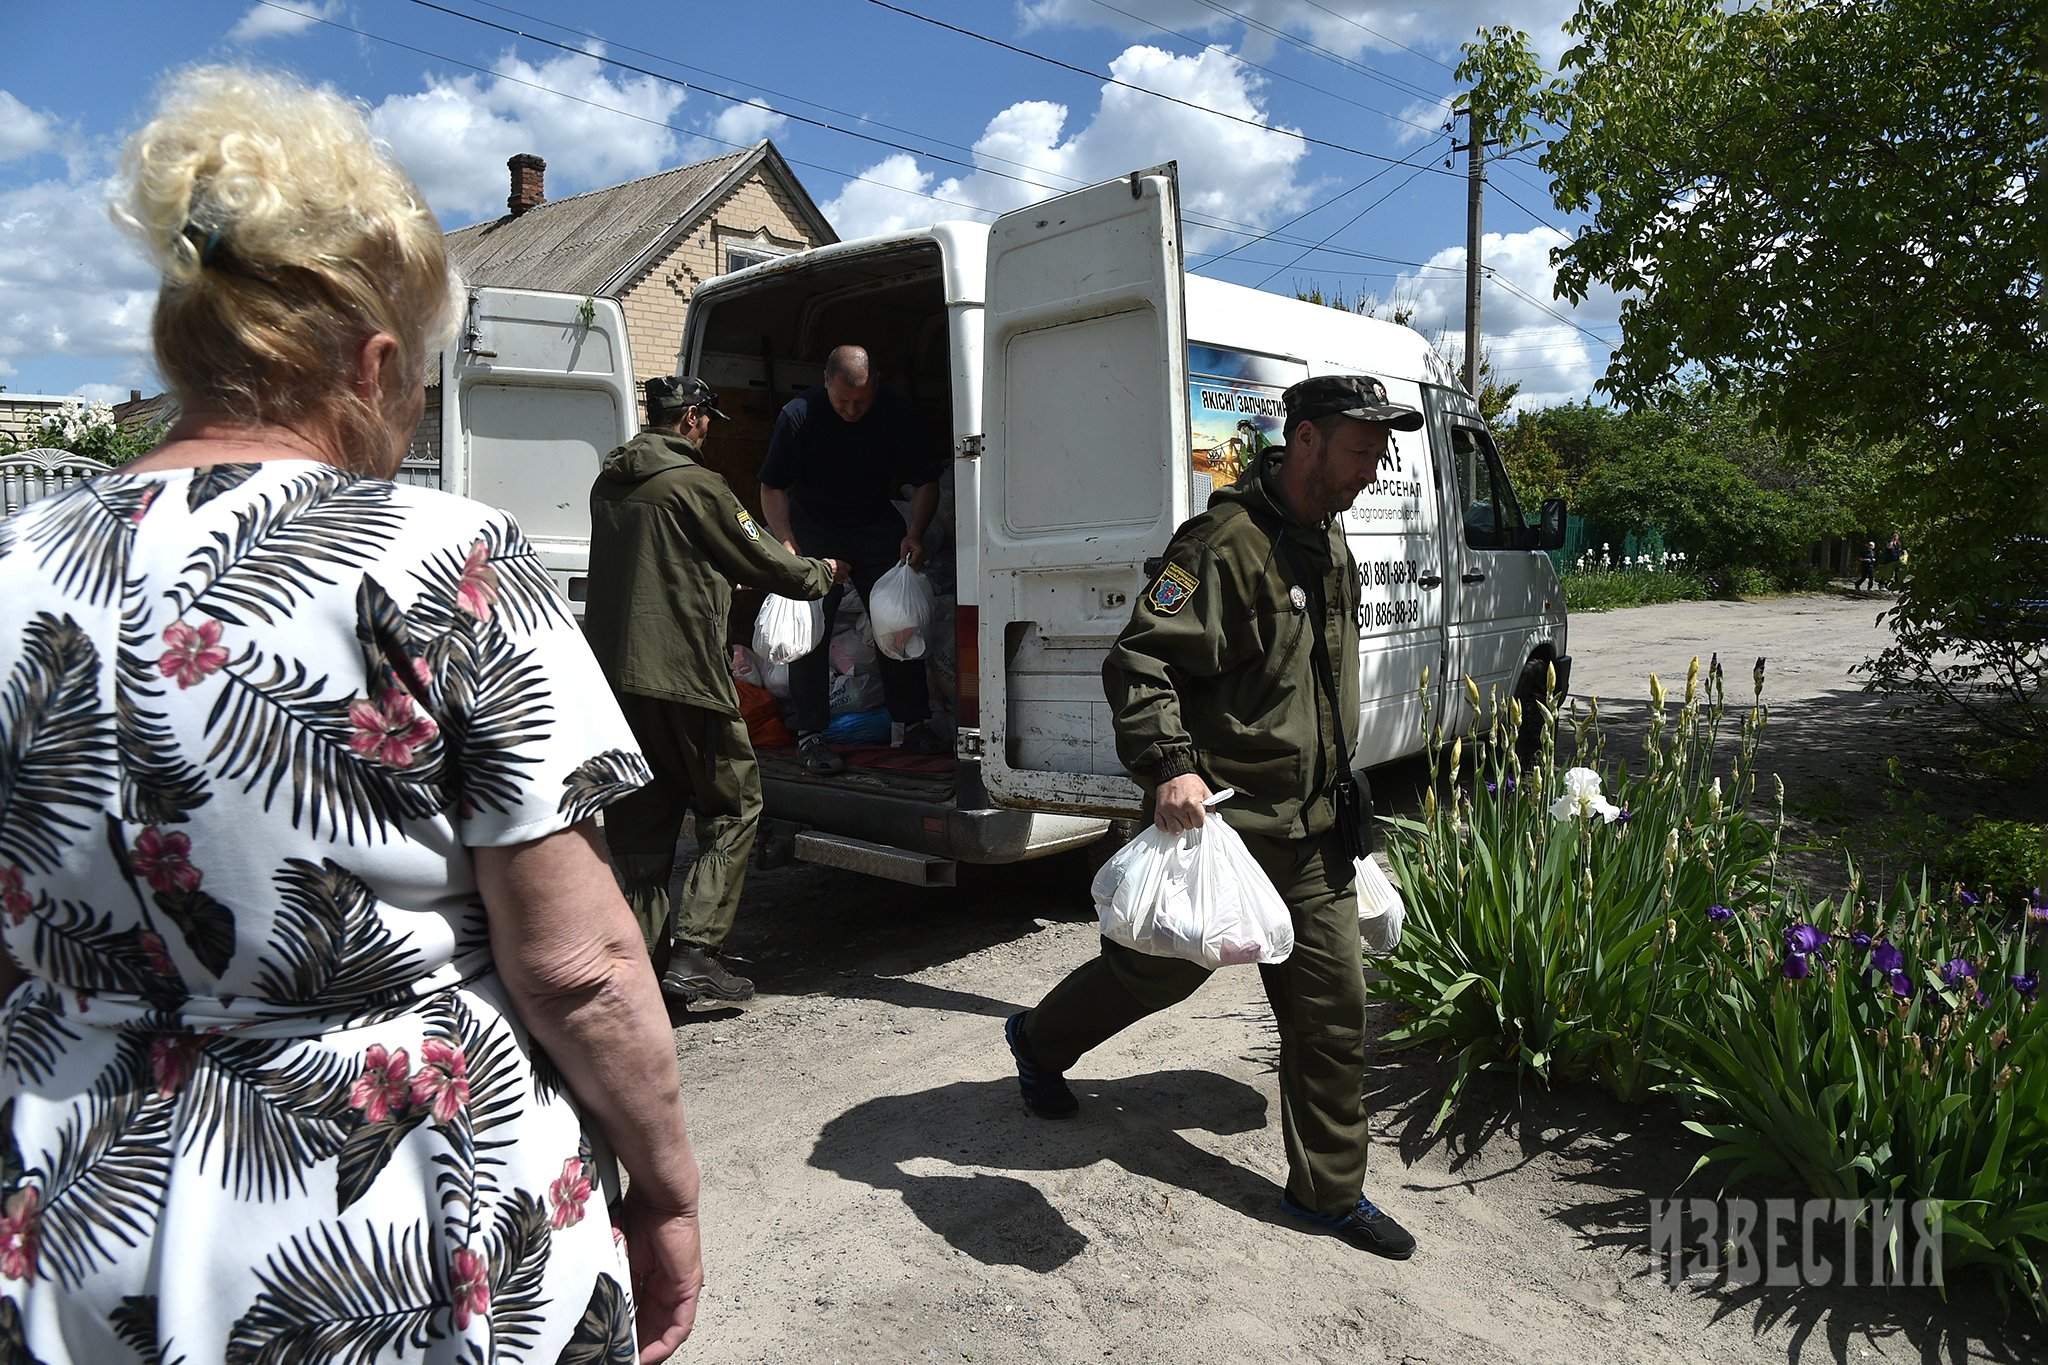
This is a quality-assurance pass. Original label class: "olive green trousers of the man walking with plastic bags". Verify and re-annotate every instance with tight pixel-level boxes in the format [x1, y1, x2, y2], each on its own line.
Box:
[1024, 831, 1366, 1214]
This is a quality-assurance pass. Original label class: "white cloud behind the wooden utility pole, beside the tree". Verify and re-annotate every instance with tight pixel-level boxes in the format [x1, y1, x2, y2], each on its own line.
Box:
[1393, 227, 1622, 409]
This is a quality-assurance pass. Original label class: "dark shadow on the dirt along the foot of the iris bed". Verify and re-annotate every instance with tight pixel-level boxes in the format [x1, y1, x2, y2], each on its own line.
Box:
[1366, 1039, 2048, 1365]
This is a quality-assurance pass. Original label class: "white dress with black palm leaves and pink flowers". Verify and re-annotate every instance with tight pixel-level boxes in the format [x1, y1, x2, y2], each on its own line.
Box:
[0, 460, 647, 1365]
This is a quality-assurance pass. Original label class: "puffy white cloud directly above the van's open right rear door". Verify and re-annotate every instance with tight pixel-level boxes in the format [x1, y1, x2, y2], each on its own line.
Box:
[823, 45, 1307, 250]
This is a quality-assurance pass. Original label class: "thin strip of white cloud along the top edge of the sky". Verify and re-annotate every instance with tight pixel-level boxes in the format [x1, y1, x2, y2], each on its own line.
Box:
[1020, 0, 1575, 66]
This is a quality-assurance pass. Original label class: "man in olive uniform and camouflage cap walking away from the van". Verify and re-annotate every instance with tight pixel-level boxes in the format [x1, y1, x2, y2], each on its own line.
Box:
[1004, 375, 1423, 1259]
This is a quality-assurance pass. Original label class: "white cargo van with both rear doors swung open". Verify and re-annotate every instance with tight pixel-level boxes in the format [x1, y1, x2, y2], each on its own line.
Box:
[444, 166, 1571, 884]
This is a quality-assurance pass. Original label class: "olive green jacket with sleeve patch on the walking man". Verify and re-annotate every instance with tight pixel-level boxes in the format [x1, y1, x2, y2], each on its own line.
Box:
[1102, 448, 1360, 839]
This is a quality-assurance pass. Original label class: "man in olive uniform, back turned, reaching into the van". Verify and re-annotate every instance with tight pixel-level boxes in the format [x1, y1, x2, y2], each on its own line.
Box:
[584, 375, 846, 1005]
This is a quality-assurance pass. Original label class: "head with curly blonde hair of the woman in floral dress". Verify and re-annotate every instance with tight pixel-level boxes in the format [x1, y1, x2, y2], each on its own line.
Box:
[113, 65, 461, 473]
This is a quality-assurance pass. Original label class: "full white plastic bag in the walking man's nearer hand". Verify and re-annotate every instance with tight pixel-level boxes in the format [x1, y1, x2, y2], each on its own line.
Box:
[1090, 788, 1294, 968]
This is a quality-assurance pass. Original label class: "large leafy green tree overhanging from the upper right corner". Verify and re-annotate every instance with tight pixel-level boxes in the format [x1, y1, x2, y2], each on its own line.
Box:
[1466, 0, 2048, 743]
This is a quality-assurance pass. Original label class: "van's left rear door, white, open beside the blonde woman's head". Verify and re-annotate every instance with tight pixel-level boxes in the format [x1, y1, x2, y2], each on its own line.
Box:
[440, 289, 639, 616]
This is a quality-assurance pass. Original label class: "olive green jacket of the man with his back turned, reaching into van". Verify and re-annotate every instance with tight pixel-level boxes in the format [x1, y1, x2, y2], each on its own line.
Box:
[584, 432, 831, 716]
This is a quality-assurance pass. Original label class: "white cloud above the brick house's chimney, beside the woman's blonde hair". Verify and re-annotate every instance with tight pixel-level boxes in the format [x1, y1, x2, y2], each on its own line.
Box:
[371, 53, 684, 227]
